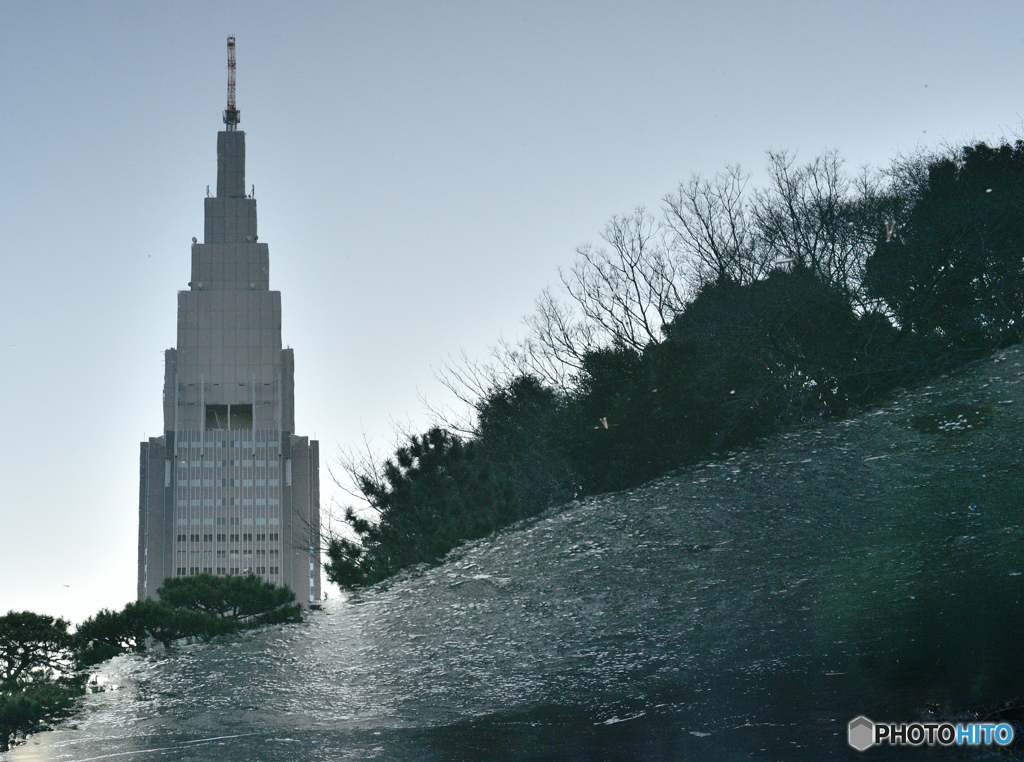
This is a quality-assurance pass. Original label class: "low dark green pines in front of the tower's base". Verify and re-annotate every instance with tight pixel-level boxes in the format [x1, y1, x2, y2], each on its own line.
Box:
[0, 575, 302, 752]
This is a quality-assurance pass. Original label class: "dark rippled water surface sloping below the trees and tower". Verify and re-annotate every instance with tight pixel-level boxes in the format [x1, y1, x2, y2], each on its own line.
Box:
[4, 348, 1024, 761]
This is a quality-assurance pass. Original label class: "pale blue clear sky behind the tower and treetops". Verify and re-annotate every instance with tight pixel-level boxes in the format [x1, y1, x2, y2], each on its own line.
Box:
[6, 0, 1024, 620]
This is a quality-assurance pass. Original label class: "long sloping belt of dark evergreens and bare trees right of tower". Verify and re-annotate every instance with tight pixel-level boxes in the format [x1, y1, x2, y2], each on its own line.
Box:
[327, 141, 1024, 588]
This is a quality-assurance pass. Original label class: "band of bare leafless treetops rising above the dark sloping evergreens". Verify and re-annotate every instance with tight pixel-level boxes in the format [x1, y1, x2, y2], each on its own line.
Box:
[437, 152, 892, 411]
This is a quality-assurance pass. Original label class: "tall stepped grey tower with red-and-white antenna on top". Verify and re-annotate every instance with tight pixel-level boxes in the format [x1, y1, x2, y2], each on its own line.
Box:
[138, 38, 321, 604]
